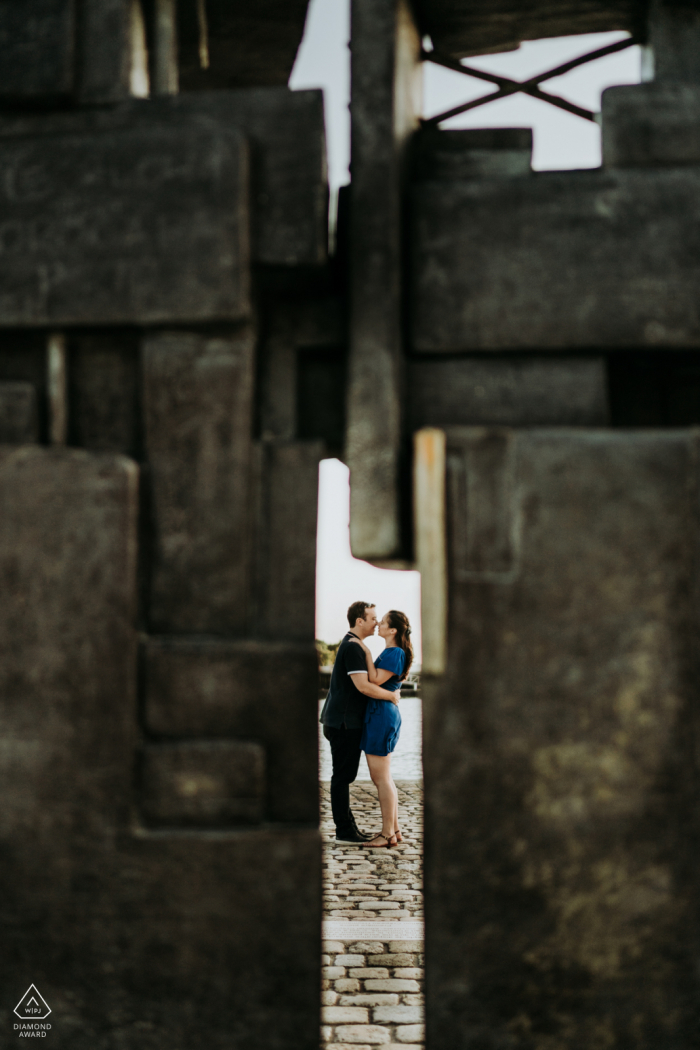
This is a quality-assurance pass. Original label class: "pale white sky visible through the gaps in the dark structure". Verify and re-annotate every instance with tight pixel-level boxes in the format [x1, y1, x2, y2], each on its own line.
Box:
[290, 0, 641, 660]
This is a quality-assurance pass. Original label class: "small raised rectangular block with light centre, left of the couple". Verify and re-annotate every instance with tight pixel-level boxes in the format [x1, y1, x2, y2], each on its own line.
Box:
[141, 740, 266, 826]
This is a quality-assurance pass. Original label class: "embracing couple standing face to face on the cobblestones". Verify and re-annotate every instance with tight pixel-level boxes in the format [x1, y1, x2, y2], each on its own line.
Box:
[321, 602, 413, 849]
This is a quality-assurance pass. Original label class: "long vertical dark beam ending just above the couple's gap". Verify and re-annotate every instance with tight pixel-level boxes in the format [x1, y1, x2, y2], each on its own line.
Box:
[346, 0, 421, 559]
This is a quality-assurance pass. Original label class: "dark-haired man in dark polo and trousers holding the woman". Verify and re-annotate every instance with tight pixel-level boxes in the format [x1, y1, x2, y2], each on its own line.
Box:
[321, 602, 398, 845]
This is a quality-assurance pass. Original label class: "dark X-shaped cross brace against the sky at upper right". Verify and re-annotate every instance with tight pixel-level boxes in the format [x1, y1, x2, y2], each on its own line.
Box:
[421, 37, 642, 127]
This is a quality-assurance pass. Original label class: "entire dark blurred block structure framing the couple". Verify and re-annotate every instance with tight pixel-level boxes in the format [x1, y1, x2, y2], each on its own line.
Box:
[0, 0, 700, 1050]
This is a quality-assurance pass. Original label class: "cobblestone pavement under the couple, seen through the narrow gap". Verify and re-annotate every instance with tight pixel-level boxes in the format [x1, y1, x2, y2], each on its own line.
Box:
[321, 781, 424, 1050]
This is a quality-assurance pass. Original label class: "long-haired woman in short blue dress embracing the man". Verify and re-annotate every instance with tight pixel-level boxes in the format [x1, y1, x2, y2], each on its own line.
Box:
[358, 609, 413, 849]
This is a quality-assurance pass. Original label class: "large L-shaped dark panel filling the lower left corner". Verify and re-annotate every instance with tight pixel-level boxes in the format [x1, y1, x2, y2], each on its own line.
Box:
[0, 447, 321, 1050]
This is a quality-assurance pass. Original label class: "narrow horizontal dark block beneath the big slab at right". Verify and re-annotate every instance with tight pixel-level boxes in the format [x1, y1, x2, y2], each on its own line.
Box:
[408, 355, 609, 431]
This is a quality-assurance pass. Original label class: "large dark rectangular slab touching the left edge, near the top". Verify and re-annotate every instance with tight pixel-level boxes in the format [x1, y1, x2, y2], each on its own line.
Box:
[0, 121, 250, 326]
